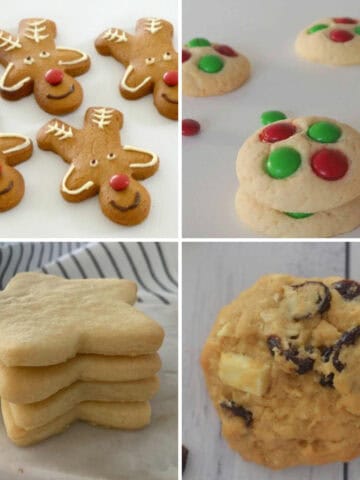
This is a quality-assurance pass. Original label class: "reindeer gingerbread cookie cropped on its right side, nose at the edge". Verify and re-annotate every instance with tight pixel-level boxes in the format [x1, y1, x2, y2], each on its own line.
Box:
[95, 18, 178, 120]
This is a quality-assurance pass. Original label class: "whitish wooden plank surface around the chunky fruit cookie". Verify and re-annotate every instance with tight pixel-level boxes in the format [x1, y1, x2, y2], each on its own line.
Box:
[183, 242, 360, 480]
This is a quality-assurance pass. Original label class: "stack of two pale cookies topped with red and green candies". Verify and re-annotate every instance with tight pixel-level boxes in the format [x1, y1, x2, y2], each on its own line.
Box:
[235, 112, 360, 237]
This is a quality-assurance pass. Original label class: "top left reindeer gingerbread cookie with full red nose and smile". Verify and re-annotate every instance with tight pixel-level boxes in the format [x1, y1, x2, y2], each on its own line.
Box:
[0, 18, 90, 115]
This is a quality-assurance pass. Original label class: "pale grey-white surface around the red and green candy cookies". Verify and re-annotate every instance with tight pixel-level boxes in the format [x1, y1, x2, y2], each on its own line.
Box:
[183, 0, 360, 237]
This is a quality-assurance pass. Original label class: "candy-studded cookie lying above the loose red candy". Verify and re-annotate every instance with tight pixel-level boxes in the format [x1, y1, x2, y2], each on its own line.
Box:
[182, 38, 250, 97]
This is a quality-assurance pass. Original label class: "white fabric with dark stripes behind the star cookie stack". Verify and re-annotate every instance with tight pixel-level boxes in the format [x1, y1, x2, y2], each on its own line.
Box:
[0, 242, 178, 304]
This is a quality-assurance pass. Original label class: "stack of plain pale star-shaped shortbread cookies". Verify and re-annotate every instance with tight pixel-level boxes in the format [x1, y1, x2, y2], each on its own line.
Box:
[0, 273, 164, 446]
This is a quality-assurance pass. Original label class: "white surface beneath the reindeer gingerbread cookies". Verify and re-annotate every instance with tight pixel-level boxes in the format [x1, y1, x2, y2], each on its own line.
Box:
[0, 0, 178, 238]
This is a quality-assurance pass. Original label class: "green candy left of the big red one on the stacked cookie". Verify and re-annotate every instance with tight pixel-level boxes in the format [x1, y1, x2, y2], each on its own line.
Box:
[265, 147, 301, 180]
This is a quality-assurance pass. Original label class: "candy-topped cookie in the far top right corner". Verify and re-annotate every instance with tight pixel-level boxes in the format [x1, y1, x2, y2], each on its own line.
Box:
[295, 17, 360, 65]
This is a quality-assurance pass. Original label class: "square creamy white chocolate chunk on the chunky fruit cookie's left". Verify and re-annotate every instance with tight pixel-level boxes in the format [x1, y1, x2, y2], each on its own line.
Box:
[218, 352, 270, 396]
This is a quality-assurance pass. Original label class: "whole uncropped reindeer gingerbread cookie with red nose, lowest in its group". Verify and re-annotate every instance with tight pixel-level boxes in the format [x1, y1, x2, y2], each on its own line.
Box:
[37, 107, 159, 225]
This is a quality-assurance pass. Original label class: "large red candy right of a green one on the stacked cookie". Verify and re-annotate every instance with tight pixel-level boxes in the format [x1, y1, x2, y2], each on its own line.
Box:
[311, 148, 349, 181]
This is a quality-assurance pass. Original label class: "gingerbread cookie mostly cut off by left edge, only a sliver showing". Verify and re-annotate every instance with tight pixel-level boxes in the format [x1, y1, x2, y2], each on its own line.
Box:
[0, 133, 33, 212]
